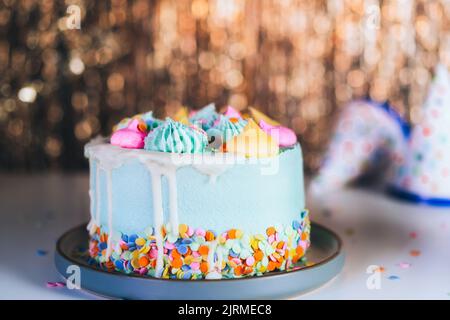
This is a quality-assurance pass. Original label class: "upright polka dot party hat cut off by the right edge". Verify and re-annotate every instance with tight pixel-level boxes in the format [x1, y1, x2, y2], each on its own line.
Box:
[389, 65, 450, 206]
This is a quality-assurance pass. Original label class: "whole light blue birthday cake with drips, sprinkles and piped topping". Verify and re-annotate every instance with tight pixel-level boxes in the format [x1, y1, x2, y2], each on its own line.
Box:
[85, 104, 310, 280]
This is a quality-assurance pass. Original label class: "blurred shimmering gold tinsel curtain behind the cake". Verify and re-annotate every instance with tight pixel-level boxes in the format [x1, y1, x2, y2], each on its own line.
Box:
[0, 0, 450, 170]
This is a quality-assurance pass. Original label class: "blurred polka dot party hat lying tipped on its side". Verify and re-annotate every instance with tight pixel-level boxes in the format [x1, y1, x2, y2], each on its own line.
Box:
[310, 100, 409, 195]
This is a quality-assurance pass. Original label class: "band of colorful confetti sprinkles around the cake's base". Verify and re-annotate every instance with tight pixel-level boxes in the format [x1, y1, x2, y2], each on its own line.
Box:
[89, 210, 311, 280]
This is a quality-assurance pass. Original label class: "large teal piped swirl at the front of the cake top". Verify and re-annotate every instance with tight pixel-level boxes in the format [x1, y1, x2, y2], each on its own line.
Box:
[144, 118, 208, 153]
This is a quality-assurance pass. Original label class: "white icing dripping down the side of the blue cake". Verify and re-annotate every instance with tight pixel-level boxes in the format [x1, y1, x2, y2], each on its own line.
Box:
[85, 138, 237, 279]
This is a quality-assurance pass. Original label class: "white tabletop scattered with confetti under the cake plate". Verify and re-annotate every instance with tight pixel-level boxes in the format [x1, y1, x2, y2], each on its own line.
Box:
[0, 174, 450, 299]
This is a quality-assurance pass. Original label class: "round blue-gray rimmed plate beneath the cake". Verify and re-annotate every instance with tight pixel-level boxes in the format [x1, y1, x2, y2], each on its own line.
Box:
[55, 223, 344, 300]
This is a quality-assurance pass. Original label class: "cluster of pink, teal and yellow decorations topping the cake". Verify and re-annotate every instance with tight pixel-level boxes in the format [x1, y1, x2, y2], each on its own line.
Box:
[111, 103, 297, 158]
